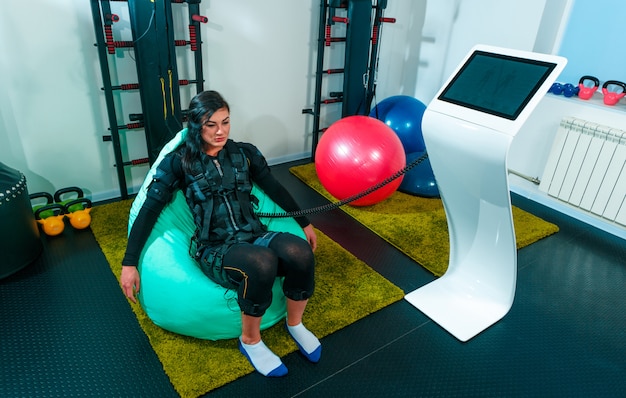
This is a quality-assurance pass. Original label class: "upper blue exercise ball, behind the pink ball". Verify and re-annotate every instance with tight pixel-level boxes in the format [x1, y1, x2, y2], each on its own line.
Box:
[370, 95, 426, 153]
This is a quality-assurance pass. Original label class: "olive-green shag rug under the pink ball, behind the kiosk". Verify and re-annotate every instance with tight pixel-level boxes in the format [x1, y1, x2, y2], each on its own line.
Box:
[290, 163, 559, 276]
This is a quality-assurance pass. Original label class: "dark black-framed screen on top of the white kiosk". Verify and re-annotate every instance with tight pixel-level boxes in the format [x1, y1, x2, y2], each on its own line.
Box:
[439, 51, 556, 120]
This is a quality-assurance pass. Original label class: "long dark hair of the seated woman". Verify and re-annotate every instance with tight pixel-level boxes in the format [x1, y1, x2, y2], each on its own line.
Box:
[180, 91, 230, 171]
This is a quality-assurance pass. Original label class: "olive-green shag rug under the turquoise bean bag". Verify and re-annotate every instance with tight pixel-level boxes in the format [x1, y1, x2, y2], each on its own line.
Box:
[91, 200, 404, 398]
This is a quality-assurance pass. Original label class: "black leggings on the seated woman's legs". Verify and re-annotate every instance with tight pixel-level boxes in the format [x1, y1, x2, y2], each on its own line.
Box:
[222, 233, 315, 317]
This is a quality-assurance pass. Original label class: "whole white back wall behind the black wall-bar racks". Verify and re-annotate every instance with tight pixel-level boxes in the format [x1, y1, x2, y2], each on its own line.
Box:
[0, 0, 425, 200]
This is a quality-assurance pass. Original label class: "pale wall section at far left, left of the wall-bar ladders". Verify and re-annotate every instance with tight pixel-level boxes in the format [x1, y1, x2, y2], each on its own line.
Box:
[0, 0, 116, 199]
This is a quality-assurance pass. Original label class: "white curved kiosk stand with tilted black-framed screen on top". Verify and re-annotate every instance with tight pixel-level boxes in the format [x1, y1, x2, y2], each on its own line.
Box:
[405, 45, 567, 341]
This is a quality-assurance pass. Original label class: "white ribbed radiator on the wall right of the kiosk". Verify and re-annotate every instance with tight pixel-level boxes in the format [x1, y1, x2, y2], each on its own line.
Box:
[539, 117, 626, 225]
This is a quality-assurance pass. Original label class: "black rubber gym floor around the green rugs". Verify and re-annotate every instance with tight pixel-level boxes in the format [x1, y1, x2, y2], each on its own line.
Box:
[0, 160, 626, 397]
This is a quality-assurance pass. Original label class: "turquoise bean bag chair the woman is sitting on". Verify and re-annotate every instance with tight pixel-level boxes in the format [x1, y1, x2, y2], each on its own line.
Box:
[128, 129, 306, 340]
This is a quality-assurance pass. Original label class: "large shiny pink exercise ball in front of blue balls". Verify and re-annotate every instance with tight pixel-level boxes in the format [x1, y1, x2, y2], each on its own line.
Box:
[315, 115, 406, 206]
